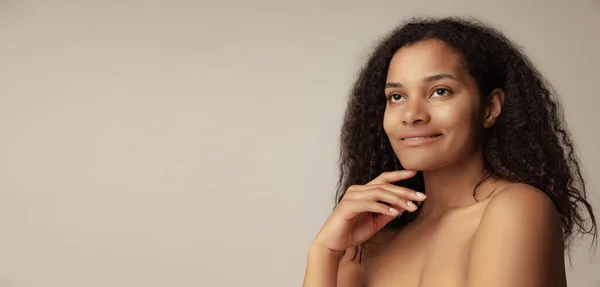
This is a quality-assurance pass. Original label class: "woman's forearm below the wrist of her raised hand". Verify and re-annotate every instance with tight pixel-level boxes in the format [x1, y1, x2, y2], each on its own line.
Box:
[303, 246, 343, 287]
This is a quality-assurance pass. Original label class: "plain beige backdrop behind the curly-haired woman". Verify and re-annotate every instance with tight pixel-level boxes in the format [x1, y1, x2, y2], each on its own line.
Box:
[0, 0, 600, 287]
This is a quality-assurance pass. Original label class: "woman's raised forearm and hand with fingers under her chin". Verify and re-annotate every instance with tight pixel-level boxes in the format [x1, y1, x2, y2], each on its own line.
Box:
[303, 170, 426, 287]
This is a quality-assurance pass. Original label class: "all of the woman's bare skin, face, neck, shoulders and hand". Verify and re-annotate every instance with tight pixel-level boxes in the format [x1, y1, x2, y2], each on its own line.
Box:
[304, 40, 566, 287]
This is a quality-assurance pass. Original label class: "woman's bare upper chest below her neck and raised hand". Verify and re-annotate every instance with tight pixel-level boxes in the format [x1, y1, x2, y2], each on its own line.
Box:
[363, 207, 481, 287]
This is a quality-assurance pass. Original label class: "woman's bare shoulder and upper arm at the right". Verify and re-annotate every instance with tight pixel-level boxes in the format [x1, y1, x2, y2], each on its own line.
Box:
[467, 185, 566, 287]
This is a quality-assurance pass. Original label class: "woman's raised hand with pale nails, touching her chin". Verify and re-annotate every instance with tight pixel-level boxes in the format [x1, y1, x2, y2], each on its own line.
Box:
[313, 170, 425, 253]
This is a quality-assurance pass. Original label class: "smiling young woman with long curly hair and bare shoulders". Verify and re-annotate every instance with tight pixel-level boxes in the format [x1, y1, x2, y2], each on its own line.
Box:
[304, 17, 597, 287]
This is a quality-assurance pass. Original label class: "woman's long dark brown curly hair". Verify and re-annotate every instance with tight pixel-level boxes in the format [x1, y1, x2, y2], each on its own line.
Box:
[336, 17, 597, 258]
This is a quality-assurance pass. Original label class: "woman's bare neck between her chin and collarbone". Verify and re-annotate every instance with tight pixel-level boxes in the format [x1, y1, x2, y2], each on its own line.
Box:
[418, 149, 485, 222]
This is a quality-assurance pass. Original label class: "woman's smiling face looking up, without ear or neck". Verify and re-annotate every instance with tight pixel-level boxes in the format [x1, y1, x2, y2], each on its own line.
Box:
[383, 40, 483, 171]
